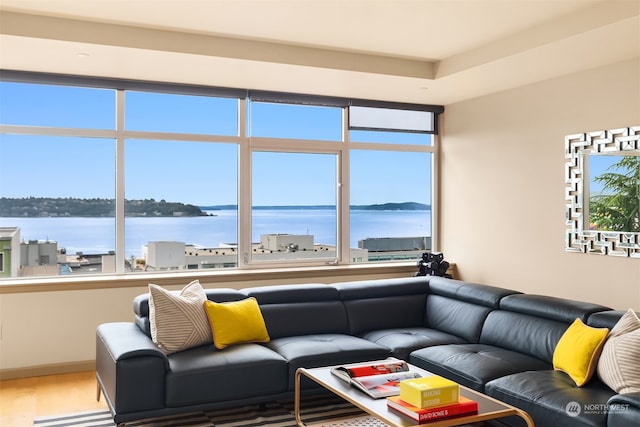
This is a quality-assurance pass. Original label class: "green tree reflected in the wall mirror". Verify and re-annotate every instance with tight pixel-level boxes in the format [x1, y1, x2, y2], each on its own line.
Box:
[589, 156, 640, 233]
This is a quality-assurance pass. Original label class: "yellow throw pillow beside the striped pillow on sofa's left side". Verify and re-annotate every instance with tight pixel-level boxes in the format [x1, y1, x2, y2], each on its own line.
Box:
[204, 297, 270, 350]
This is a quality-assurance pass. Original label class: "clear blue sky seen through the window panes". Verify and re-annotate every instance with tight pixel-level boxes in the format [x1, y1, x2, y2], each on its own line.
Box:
[0, 83, 430, 205]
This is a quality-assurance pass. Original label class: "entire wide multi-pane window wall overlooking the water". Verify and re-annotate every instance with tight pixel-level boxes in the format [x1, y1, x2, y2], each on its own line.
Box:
[0, 75, 441, 278]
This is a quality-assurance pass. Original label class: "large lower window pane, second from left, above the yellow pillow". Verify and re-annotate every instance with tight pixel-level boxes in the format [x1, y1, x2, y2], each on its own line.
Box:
[124, 139, 238, 271]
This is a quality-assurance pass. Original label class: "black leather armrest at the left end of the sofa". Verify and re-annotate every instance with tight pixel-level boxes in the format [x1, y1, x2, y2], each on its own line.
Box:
[96, 322, 169, 416]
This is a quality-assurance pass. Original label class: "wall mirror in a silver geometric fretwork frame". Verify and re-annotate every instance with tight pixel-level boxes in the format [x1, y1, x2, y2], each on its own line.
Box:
[565, 126, 640, 258]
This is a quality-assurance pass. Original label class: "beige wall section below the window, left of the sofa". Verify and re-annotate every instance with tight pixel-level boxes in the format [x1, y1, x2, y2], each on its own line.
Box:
[0, 288, 140, 378]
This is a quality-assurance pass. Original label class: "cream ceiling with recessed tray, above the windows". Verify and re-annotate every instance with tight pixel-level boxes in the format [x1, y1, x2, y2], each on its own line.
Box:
[0, 0, 640, 105]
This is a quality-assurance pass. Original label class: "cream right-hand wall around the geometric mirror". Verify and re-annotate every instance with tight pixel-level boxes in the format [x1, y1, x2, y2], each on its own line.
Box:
[440, 60, 640, 310]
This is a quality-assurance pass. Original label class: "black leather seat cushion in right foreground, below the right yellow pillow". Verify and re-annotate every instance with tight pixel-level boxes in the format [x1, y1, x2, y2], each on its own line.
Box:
[485, 370, 614, 427]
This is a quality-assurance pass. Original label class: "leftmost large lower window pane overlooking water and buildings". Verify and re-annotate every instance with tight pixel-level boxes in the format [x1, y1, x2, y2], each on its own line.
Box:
[0, 134, 116, 277]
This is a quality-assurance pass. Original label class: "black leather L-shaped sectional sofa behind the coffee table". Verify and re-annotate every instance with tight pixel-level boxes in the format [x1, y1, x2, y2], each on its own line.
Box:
[96, 276, 640, 427]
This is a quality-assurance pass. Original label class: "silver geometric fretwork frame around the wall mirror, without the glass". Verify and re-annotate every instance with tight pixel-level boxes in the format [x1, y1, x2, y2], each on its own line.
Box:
[564, 126, 640, 258]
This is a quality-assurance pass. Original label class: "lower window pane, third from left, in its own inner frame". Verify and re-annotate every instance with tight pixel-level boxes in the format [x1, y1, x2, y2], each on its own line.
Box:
[251, 151, 338, 261]
